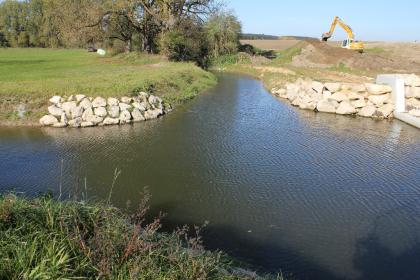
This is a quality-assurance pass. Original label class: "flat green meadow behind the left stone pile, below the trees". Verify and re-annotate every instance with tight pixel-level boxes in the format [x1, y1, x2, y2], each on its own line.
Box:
[0, 49, 216, 124]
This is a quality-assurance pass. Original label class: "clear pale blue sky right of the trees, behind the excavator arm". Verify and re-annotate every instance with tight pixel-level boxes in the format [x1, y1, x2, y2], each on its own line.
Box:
[225, 0, 420, 41]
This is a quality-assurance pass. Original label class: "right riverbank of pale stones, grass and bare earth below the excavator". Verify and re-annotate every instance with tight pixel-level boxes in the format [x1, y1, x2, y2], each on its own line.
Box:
[214, 40, 420, 123]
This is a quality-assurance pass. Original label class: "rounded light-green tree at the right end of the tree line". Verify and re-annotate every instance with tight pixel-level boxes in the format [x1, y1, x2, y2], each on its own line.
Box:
[205, 12, 241, 58]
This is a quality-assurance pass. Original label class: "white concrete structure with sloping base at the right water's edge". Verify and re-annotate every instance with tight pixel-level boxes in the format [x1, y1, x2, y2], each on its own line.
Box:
[376, 74, 420, 128]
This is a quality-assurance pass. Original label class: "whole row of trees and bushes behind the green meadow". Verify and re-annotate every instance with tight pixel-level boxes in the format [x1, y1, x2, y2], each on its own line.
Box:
[0, 0, 241, 66]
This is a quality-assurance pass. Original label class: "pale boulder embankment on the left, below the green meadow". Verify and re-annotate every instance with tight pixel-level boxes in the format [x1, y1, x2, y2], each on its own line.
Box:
[39, 92, 172, 127]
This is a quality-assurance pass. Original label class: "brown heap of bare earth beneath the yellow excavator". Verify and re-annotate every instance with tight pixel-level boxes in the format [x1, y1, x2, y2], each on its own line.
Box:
[292, 40, 420, 72]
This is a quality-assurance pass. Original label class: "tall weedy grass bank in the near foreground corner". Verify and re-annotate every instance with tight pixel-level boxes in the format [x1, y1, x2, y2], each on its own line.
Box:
[0, 195, 281, 279]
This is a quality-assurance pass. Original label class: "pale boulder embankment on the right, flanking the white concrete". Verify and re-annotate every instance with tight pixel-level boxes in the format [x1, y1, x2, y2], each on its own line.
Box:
[272, 75, 420, 119]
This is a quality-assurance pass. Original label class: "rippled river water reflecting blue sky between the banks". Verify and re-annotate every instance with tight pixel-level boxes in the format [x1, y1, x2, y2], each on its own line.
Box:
[0, 75, 420, 279]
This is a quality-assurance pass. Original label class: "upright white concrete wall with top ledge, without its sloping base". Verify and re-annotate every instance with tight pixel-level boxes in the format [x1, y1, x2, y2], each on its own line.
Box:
[376, 74, 406, 113]
